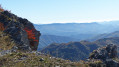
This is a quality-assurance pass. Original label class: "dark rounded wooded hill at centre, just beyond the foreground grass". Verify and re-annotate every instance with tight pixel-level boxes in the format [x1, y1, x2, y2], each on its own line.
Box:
[41, 42, 98, 61]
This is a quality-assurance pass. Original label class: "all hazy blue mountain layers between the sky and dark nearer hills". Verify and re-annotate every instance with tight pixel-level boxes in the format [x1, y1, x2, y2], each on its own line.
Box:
[34, 21, 119, 50]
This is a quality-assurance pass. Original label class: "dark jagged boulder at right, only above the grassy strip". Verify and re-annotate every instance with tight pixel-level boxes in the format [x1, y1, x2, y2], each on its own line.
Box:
[89, 44, 118, 61]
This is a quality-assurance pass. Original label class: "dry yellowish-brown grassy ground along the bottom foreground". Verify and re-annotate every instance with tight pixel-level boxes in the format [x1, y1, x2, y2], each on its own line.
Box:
[0, 52, 88, 67]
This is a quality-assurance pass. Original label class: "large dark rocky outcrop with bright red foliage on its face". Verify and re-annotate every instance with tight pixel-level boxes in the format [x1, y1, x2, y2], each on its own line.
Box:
[0, 11, 40, 50]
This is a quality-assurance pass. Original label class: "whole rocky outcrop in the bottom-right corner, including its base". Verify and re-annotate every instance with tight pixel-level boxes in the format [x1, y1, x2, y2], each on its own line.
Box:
[89, 44, 119, 67]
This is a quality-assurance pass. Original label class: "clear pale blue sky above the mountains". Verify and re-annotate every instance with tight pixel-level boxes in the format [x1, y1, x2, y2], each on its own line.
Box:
[0, 0, 119, 24]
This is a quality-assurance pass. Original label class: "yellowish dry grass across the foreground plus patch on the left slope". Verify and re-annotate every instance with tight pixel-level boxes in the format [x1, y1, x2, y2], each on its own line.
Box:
[0, 31, 88, 67]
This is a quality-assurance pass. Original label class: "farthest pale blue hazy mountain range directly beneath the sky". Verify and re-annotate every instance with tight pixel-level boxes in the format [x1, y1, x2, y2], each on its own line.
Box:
[34, 21, 119, 40]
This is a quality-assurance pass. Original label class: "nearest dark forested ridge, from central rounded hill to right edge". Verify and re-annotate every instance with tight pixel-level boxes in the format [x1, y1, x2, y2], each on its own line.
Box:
[41, 37, 119, 61]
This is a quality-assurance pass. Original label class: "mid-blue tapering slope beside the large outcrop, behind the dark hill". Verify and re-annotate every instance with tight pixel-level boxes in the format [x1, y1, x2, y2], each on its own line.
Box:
[38, 35, 80, 50]
